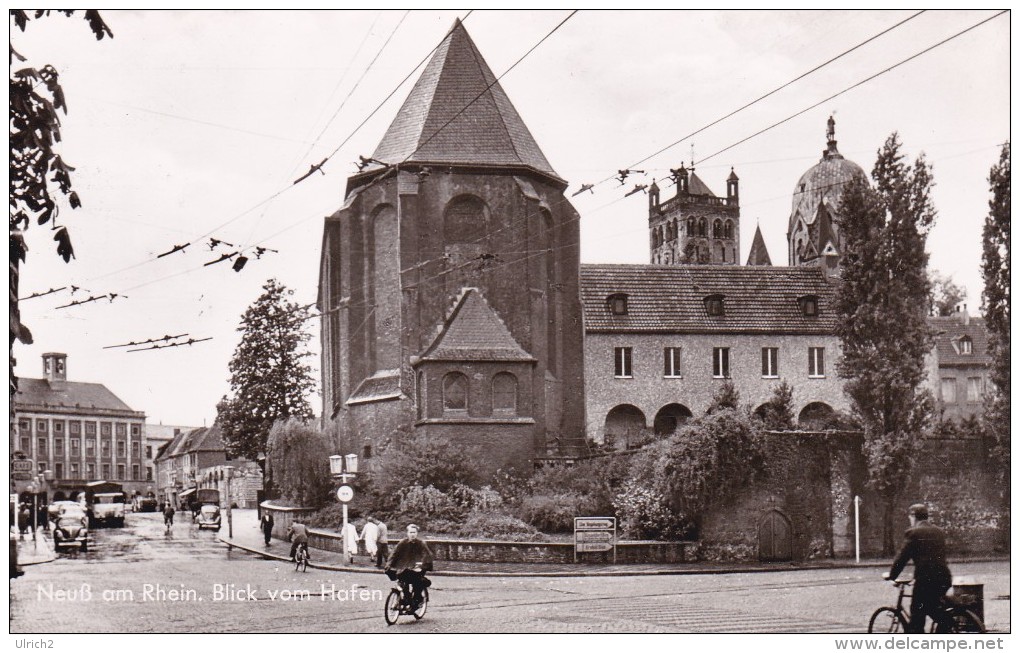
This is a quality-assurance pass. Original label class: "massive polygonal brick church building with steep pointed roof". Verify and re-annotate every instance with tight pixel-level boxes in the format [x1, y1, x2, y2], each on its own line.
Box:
[318, 20, 584, 470]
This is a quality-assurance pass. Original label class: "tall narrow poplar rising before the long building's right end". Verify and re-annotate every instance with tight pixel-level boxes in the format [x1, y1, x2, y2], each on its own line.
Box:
[835, 134, 935, 554]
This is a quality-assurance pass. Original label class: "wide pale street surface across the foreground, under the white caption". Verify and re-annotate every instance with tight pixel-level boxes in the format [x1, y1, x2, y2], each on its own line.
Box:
[10, 514, 1010, 634]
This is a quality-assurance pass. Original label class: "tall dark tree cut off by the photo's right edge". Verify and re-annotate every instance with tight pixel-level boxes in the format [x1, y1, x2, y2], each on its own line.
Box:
[981, 142, 1011, 537]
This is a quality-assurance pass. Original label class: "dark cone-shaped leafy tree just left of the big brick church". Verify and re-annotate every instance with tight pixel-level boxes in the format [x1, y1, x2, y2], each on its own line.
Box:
[216, 279, 315, 460]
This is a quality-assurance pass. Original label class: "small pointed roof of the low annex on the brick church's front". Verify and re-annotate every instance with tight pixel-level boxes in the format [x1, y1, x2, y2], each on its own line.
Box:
[421, 288, 534, 362]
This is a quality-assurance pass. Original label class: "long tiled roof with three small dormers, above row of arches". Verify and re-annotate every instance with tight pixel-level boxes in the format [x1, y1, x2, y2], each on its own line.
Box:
[580, 264, 835, 335]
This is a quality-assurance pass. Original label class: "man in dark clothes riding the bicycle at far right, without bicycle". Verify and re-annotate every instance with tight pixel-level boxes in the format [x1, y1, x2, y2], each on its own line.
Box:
[886, 503, 953, 633]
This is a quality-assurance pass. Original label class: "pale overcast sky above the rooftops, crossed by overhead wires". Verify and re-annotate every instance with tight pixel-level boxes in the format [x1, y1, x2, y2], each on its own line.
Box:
[11, 10, 1011, 425]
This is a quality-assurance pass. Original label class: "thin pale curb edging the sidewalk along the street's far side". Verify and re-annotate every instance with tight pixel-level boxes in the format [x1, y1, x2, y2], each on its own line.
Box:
[217, 537, 1009, 577]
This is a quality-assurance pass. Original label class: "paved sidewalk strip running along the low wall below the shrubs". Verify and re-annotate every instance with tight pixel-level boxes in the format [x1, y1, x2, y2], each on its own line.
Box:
[219, 510, 918, 576]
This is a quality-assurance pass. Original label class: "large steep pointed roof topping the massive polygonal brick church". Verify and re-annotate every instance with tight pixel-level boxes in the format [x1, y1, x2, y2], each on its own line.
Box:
[369, 20, 562, 181]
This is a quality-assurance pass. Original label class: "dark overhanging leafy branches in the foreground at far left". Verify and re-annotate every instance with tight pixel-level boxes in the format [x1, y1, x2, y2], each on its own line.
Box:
[7, 9, 113, 433]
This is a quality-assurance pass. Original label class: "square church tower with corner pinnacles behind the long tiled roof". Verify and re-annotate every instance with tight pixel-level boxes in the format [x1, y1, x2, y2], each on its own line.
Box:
[648, 163, 741, 265]
